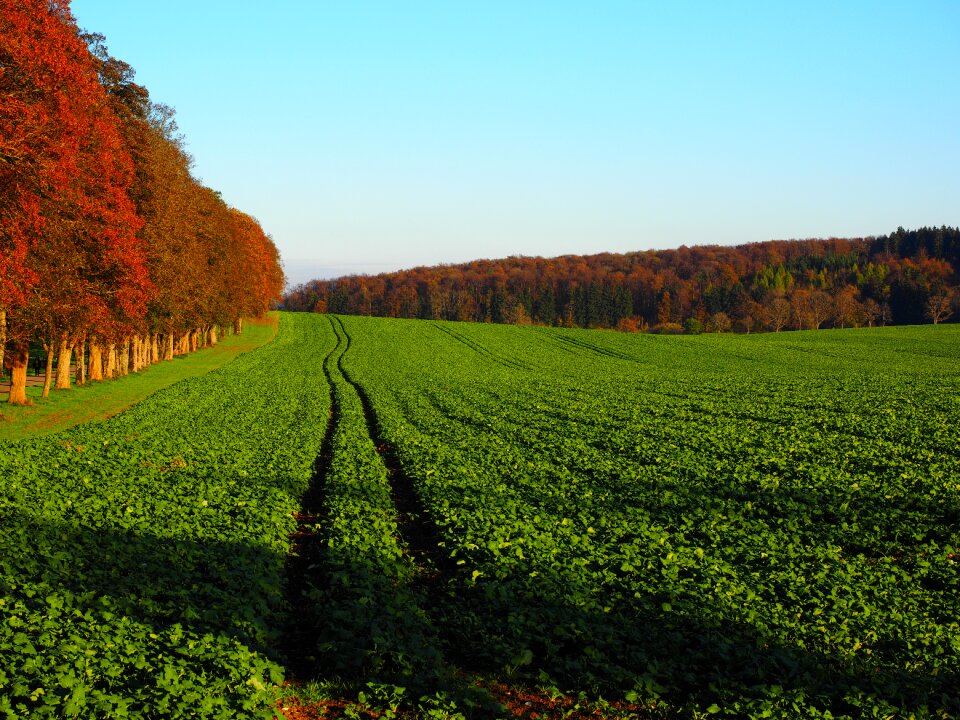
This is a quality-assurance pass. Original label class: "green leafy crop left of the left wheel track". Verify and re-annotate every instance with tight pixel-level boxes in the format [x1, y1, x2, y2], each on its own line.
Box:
[0, 316, 336, 718]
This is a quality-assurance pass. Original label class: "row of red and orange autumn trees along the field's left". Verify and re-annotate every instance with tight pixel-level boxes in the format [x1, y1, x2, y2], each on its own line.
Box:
[0, 0, 284, 404]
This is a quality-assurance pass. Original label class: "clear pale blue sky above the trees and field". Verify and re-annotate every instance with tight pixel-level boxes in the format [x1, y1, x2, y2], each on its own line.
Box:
[72, 0, 960, 282]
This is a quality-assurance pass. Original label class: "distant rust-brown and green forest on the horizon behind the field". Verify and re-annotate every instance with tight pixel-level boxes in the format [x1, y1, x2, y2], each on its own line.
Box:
[283, 227, 960, 333]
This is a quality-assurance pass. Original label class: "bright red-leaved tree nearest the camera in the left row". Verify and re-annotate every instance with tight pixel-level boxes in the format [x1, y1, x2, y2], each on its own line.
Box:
[0, 0, 150, 404]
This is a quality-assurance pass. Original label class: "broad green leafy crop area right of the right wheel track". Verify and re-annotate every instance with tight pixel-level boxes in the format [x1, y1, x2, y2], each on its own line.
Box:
[334, 317, 960, 718]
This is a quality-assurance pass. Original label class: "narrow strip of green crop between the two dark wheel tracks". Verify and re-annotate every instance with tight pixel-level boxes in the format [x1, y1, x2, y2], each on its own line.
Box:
[307, 320, 443, 697]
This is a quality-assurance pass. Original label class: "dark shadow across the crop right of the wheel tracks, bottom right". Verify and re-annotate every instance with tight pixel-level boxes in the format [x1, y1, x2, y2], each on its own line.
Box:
[437, 573, 960, 717]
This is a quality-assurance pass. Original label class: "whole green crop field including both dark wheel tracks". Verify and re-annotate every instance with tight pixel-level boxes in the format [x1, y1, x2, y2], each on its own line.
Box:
[0, 315, 960, 718]
